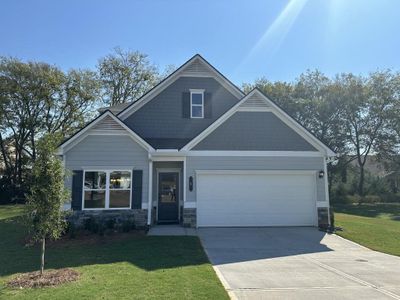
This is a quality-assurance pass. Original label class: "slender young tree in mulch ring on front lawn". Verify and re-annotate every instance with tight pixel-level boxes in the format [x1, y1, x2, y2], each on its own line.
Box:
[26, 135, 68, 274]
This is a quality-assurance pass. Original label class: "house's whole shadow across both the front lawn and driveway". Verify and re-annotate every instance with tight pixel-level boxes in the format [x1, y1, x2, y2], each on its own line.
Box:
[0, 207, 332, 276]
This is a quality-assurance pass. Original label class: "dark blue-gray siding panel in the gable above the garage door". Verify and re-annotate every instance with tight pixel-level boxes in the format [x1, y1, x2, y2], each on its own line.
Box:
[193, 112, 316, 151]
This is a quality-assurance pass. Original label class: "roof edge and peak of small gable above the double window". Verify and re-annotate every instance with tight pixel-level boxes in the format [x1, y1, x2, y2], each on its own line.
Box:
[58, 110, 154, 155]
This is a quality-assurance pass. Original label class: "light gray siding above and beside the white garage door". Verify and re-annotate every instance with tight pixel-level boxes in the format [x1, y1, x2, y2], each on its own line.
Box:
[186, 156, 326, 202]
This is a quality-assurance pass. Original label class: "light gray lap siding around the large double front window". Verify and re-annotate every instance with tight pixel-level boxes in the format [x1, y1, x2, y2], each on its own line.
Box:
[65, 135, 149, 207]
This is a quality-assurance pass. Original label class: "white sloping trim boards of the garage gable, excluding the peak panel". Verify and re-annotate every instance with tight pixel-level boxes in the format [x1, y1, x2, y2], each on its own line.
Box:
[182, 89, 335, 156]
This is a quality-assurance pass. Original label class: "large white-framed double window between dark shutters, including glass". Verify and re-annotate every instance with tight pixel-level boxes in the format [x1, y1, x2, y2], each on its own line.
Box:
[83, 170, 132, 209]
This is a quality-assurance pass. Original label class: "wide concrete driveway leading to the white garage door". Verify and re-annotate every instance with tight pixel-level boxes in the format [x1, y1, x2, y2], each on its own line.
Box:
[198, 227, 400, 300]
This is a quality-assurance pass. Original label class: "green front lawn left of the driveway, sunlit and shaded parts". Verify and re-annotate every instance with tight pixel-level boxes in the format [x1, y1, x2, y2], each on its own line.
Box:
[0, 206, 228, 299]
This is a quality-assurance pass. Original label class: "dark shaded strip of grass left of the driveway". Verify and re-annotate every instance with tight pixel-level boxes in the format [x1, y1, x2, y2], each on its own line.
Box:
[0, 217, 208, 276]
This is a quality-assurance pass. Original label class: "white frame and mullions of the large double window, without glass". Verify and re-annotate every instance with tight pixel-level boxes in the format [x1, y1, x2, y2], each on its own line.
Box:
[82, 167, 133, 210]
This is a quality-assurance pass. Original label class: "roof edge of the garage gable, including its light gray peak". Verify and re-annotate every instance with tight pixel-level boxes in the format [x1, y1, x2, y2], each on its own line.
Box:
[181, 88, 336, 157]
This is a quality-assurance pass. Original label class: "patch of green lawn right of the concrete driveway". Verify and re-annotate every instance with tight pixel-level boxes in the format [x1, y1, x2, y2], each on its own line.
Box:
[334, 204, 400, 256]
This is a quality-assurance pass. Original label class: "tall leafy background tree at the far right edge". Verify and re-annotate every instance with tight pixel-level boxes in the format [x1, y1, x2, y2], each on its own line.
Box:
[336, 71, 399, 196]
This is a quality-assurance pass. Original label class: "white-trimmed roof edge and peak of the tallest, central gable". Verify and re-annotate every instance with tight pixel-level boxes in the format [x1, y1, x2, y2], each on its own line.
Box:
[117, 54, 245, 120]
